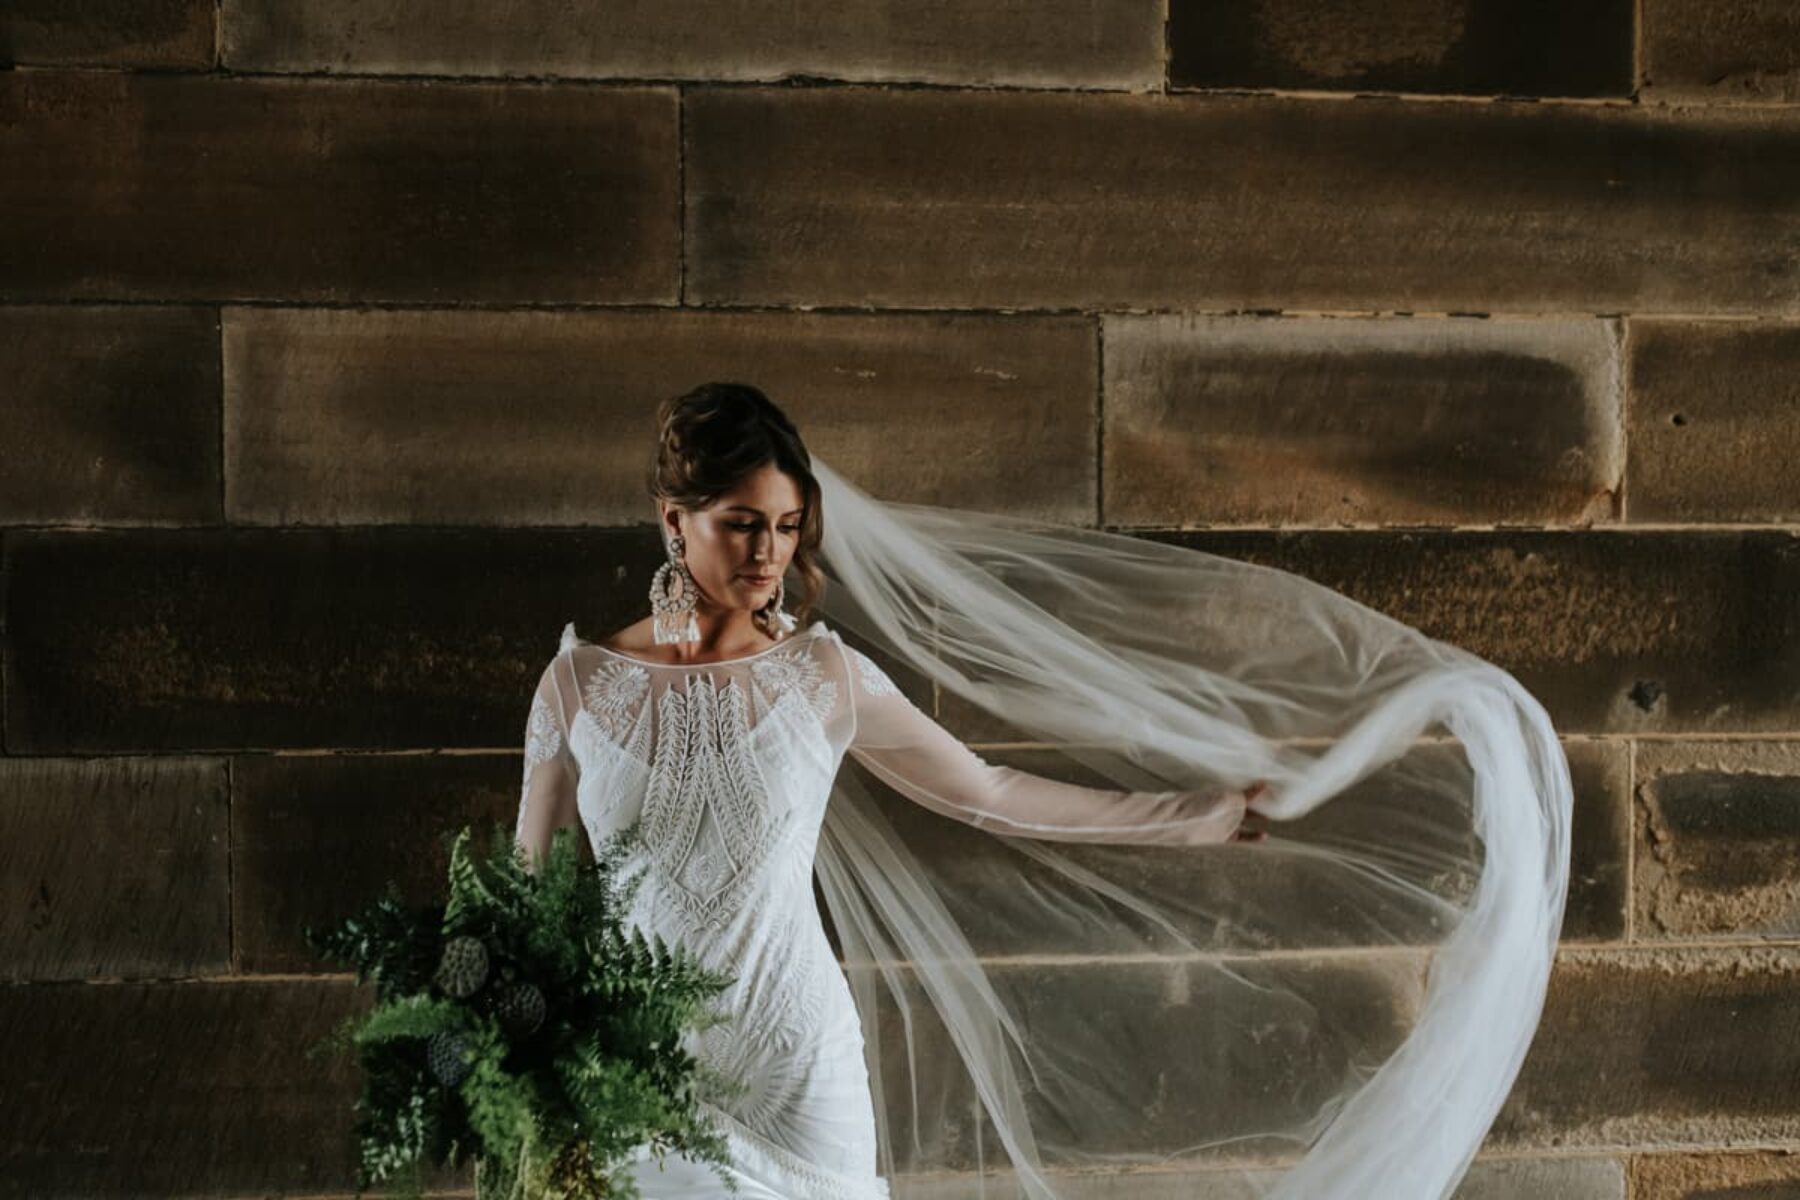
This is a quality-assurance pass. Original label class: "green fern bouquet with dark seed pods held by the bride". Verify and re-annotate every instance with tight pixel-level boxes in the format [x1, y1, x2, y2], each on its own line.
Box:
[304, 822, 742, 1200]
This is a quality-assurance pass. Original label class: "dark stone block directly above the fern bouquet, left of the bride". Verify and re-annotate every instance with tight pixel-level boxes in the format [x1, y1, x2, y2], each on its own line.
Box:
[230, 755, 525, 973]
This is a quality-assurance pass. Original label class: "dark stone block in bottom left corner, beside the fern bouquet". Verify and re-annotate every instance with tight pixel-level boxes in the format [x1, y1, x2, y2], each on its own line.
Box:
[0, 979, 374, 1198]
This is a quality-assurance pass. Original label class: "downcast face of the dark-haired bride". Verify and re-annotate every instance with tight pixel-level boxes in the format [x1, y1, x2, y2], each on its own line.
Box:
[661, 462, 803, 612]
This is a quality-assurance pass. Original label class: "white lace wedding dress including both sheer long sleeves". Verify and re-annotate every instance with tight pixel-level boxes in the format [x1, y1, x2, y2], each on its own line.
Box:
[517, 621, 1238, 1200]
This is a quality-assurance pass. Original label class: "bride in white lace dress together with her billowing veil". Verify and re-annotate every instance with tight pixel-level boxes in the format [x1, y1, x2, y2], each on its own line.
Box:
[517, 383, 1566, 1200]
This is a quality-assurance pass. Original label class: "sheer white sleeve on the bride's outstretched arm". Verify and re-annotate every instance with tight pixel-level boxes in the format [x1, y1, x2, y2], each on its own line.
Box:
[841, 642, 1244, 846]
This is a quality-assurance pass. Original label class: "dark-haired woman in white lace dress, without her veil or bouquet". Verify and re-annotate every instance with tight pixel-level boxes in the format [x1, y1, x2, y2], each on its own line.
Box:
[518, 387, 1262, 1200]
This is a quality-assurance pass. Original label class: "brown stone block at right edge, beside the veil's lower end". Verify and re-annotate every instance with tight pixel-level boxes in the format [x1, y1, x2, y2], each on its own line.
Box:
[1489, 946, 1800, 1150]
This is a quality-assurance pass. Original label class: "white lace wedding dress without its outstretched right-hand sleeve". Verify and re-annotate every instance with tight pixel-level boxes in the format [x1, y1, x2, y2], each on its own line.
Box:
[518, 624, 887, 1200]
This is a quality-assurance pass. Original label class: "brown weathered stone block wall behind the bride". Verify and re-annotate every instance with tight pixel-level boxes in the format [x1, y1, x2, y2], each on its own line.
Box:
[0, 0, 1800, 1200]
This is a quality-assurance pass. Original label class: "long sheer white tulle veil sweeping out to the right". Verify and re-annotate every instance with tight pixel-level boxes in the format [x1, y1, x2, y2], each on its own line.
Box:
[812, 457, 1571, 1200]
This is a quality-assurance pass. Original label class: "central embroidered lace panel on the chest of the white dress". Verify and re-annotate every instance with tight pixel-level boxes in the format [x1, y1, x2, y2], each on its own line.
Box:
[644, 675, 776, 930]
